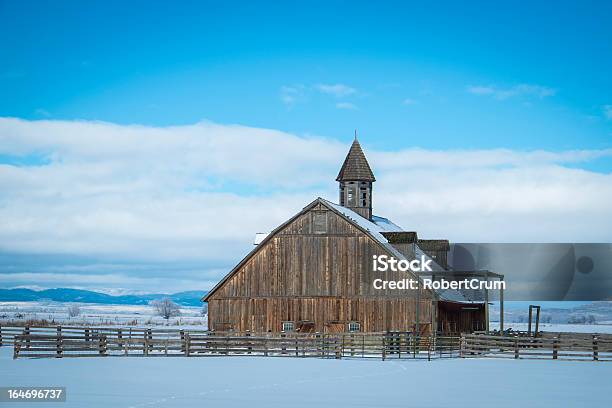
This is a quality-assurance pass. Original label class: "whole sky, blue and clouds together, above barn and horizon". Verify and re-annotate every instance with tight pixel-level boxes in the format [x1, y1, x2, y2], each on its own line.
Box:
[0, 0, 612, 290]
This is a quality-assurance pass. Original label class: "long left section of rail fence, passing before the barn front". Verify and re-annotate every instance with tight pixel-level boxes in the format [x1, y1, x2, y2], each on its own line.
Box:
[0, 326, 460, 360]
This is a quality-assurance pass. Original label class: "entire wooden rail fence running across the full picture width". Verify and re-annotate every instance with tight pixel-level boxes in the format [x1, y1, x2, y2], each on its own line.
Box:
[0, 326, 612, 361]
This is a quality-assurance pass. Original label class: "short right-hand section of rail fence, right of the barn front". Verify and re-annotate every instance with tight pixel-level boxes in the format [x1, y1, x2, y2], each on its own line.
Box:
[461, 333, 612, 361]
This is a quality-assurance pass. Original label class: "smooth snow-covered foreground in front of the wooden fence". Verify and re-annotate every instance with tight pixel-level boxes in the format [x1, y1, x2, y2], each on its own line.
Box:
[0, 347, 612, 408]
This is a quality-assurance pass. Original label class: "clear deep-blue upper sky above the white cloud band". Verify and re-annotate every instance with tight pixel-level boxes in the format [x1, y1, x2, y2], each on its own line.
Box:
[0, 1, 612, 150]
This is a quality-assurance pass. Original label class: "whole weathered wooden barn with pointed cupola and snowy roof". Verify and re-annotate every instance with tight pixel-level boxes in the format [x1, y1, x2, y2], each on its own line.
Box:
[203, 139, 494, 334]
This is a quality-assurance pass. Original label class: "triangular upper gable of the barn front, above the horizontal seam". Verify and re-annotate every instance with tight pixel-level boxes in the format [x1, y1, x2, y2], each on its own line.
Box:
[203, 198, 433, 301]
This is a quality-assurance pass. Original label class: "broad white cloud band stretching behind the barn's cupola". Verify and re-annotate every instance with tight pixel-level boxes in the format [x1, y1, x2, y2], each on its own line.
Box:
[0, 118, 612, 287]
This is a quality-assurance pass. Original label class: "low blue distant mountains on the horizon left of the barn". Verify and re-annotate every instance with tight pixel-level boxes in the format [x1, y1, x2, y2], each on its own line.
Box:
[0, 288, 207, 306]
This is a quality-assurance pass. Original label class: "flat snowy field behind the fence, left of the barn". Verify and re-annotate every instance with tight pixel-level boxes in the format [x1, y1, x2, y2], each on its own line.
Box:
[0, 302, 207, 328]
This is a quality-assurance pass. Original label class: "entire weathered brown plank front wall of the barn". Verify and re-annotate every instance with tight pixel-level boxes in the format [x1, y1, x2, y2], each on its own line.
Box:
[208, 204, 432, 332]
